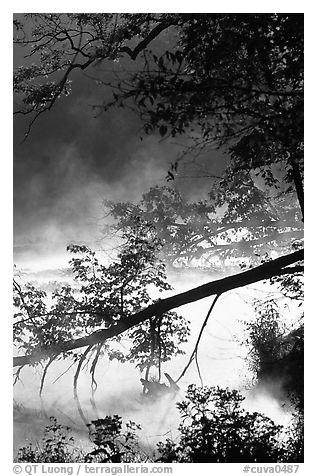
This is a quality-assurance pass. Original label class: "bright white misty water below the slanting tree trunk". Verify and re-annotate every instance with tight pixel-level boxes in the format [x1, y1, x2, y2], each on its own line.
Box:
[14, 258, 294, 452]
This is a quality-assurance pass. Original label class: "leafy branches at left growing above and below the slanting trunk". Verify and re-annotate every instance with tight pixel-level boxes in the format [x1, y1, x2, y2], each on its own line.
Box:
[14, 217, 189, 376]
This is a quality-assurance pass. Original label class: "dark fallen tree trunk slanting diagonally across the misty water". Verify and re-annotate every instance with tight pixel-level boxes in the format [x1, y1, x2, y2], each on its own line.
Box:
[13, 250, 304, 367]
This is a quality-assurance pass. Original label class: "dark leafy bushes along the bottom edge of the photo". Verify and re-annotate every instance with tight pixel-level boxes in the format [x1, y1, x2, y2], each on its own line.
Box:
[16, 385, 303, 463]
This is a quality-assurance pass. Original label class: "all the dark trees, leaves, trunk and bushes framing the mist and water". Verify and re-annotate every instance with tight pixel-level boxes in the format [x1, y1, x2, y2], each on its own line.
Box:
[14, 14, 304, 462]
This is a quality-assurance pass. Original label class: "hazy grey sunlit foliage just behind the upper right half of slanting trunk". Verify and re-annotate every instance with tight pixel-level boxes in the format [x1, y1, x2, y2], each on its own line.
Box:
[104, 184, 303, 270]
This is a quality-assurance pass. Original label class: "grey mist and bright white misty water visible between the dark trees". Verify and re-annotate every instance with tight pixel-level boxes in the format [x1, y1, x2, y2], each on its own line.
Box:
[14, 21, 296, 451]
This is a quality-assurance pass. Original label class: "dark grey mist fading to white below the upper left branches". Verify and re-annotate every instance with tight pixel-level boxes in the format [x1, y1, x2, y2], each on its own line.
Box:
[14, 34, 225, 268]
